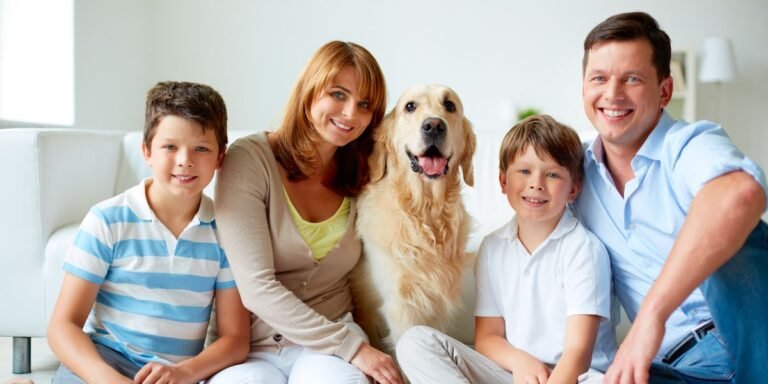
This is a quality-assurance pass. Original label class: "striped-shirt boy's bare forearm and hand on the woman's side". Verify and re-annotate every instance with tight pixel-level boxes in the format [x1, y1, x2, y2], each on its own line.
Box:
[134, 288, 251, 383]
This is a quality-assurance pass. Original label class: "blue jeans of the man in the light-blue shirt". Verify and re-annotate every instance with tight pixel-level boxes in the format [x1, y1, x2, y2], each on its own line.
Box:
[651, 221, 768, 383]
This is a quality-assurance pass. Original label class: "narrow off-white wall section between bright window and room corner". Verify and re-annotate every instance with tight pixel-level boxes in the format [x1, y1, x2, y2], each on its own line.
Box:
[75, 0, 154, 130]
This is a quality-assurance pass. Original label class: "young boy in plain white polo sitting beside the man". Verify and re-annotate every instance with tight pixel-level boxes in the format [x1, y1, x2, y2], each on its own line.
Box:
[397, 115, 616, 384]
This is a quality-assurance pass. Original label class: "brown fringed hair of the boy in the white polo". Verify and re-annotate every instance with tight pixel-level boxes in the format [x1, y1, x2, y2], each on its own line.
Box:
[499, 115, 584, 185]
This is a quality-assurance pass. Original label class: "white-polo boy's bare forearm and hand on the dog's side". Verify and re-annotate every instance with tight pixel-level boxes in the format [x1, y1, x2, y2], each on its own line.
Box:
[475, 316, 549, 383]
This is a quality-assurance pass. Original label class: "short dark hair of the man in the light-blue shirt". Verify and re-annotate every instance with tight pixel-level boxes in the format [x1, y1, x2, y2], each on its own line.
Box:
[582, 12, 672, 82]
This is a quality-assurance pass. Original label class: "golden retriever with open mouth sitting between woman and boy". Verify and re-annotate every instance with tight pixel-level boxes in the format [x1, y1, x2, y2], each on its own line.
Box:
[352, 85, 475, 349]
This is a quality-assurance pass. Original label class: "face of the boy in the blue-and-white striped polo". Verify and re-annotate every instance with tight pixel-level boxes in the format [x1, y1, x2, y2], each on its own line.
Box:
[141, 115, 224, 199]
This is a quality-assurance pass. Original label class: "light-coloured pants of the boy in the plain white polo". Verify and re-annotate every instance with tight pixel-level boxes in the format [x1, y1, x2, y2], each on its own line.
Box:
[397, 326, 603, 384]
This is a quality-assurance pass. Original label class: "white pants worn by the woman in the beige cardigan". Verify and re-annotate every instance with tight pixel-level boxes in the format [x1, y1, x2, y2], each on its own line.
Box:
[207, 314, 370, 384]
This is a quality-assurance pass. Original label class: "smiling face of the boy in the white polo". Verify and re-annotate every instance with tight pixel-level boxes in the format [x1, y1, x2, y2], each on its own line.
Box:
[499, 145, 579, 230]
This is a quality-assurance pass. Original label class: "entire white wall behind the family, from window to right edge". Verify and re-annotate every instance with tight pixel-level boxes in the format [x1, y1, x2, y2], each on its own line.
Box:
[75, 0, 768, 222]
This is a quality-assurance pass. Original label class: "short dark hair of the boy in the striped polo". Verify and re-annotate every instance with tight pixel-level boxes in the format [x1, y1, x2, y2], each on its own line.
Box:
[144, 81, 227, 152]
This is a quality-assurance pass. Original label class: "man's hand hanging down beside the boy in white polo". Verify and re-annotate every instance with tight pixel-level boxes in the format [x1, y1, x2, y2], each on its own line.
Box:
[604, 310, 665, 384]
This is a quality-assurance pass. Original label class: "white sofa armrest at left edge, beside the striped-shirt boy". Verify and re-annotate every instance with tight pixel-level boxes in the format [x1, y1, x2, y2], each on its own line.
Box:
[0, 128, 124, 336]
